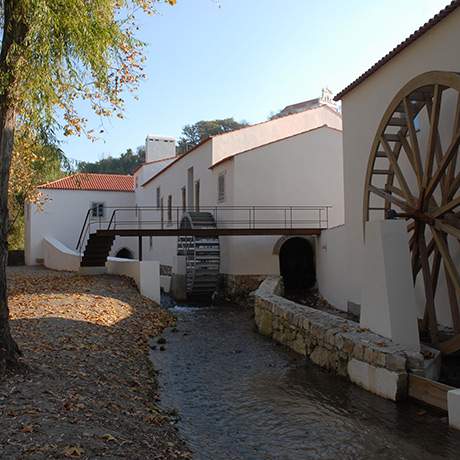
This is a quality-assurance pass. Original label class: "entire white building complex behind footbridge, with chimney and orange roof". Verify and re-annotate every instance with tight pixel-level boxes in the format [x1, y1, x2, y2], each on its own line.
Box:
[26, 91, 344, 300]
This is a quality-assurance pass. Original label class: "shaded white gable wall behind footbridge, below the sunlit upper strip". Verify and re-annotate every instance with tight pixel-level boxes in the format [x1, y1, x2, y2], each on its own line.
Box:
[220, 127, 344, 275]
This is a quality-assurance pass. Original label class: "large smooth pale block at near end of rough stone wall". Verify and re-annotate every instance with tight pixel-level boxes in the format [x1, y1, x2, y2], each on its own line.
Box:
[347, 359, 407, 401]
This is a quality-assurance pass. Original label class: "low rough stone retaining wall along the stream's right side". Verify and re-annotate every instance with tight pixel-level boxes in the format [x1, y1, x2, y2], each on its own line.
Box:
[254, 277, 424, 401]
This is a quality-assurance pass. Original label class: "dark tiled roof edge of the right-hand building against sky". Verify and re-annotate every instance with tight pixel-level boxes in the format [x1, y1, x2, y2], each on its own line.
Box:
[334, 0, 460, 101]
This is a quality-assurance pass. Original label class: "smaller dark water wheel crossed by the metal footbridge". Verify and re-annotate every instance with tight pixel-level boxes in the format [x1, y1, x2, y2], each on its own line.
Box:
[177, 212, 220, 298]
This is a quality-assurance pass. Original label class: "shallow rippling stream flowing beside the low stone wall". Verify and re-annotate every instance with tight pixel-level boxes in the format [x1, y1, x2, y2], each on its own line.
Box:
[151, 305, 460, 460]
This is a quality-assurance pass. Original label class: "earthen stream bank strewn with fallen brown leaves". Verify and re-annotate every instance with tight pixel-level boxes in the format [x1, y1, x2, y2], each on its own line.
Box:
[0, 268, 190, 459]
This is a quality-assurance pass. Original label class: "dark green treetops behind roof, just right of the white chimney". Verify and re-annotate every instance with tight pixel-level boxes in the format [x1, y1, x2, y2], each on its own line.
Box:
[177, 118, 248, 154]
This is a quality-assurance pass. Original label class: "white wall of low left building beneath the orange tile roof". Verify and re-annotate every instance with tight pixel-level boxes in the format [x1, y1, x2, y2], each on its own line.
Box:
[25, 189, 137, 265]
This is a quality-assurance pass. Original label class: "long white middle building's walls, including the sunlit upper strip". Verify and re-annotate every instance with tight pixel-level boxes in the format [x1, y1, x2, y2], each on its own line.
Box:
[136, 106, 344, 282]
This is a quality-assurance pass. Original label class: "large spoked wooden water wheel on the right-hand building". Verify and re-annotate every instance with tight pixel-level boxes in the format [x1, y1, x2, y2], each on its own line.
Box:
[364, 71, 460, 353]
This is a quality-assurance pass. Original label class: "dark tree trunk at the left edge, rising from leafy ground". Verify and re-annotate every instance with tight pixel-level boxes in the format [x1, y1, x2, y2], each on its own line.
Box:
[0, 0, 27, 372]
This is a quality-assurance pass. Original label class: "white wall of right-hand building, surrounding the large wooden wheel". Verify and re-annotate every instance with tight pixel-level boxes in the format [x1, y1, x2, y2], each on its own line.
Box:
[324, 10, 460, 320]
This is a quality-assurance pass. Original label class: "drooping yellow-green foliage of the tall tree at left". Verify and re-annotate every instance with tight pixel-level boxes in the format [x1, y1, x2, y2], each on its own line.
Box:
[0, 0, 175, 247]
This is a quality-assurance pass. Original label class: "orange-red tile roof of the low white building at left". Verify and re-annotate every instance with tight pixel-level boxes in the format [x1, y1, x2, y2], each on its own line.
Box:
[38, 173, 134, 192]
